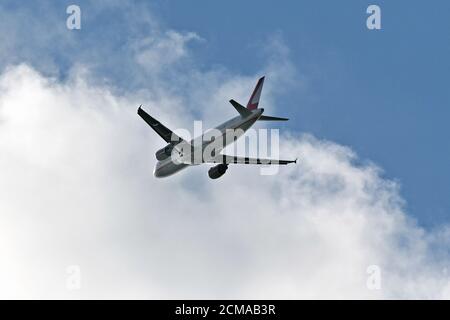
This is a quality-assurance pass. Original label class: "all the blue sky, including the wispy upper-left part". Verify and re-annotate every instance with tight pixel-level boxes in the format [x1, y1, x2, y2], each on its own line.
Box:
[2, 0, 450, 226]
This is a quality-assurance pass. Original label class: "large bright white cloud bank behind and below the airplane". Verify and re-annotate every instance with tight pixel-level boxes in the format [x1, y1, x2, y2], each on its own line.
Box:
[0, 65, 450, 298]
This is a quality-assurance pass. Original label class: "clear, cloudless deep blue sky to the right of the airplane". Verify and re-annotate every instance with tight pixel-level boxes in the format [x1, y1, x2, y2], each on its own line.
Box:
[154, 0, 450, 226]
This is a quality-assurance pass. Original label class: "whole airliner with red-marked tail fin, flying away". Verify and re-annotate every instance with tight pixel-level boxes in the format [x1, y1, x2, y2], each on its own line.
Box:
[137, 77, 297, 179]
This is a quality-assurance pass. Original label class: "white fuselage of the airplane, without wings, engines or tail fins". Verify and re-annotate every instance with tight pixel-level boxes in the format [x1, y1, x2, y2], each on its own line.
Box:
[153, 109, 264, 178]
